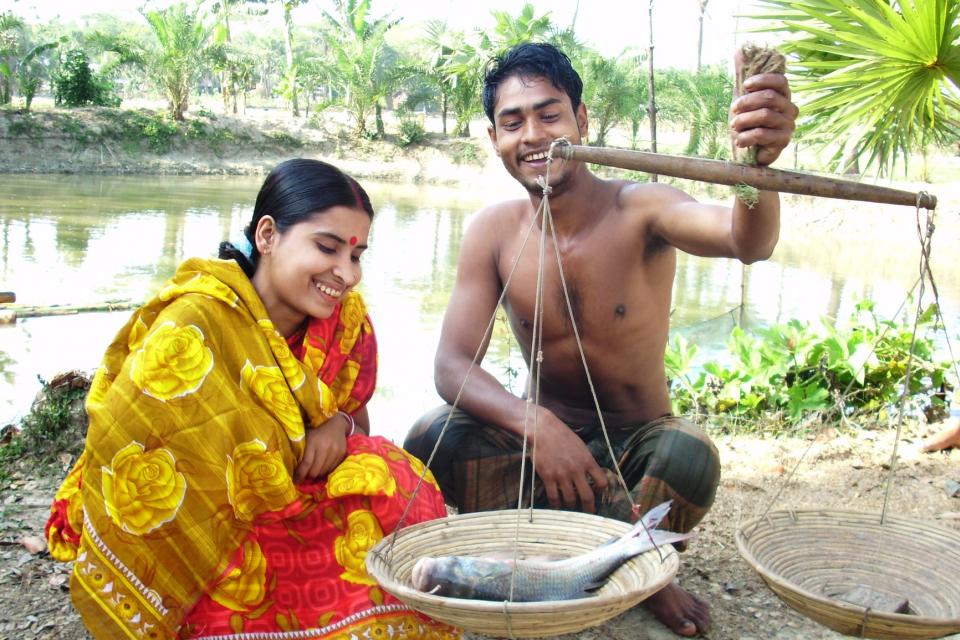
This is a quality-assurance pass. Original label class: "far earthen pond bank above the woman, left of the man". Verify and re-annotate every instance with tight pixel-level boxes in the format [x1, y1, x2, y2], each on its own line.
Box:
[0, 106, 499, 185]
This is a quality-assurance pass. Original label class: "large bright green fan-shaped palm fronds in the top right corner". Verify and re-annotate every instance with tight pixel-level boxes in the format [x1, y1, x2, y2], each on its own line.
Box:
[753, 0, 960, 174]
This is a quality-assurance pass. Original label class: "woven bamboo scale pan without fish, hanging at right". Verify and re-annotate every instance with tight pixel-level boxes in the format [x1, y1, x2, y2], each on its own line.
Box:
[736, 510, 960, 639]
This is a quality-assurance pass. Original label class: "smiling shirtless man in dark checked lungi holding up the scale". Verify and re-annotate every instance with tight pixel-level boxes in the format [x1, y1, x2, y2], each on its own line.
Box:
[404, 44, 797, 636]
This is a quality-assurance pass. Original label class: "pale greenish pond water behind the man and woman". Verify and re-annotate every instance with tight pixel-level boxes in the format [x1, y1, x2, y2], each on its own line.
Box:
[0, 175, 960, 441]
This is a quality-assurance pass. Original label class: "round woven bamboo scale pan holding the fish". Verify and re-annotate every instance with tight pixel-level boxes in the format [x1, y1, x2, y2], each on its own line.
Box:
[367, 509, 680, 638]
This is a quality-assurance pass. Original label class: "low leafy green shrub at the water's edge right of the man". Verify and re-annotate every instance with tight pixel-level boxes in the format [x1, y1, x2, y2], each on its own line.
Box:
[665, 302, 948, 431]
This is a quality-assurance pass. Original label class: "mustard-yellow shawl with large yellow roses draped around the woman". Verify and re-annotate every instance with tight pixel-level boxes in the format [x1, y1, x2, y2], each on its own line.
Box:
[49, 259, 352, 638]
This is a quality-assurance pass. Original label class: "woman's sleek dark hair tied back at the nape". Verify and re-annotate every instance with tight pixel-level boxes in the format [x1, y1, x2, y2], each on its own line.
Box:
[219, 158, 373, 278]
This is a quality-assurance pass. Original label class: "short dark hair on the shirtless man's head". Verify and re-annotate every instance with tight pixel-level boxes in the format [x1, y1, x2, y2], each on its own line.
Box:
[483, 42, 583, 125]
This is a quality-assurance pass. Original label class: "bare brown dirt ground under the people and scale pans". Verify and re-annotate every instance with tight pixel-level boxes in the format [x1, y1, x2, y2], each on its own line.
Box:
[0, 425, 960, 640]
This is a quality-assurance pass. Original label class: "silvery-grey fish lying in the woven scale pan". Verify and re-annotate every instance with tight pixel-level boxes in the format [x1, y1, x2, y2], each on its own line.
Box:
[410, 500, 692, 602]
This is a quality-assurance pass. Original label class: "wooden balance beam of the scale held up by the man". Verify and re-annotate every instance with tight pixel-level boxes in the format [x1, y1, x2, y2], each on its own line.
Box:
[554, 142, 937, 209]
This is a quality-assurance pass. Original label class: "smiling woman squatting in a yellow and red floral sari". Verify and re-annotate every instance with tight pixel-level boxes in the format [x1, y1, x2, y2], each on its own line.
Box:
[46, 159, 454, 638]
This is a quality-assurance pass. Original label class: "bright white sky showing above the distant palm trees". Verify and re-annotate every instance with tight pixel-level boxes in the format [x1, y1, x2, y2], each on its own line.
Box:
[0, 0, 761, 69]
